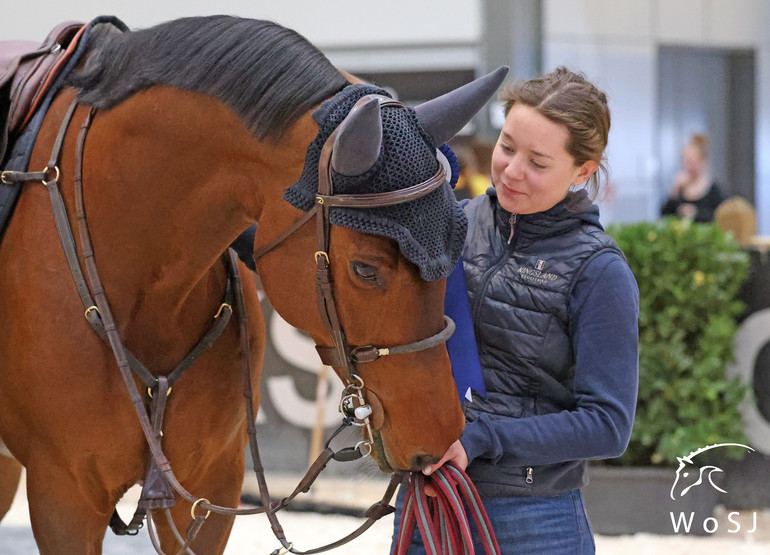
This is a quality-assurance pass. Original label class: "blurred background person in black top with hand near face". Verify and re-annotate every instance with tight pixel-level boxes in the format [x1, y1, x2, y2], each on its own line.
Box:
[660, 133, 725, 223]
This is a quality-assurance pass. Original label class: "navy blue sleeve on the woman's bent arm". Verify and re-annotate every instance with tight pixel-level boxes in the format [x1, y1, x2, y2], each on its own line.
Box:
[460, 252, 639, 465]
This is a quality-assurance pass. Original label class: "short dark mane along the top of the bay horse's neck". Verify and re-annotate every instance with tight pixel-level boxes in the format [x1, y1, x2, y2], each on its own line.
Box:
[68, 15, 348, 141]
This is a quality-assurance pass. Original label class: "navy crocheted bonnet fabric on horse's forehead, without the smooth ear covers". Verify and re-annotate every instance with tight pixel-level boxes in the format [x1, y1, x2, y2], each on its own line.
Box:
[283, 85, 468, 281]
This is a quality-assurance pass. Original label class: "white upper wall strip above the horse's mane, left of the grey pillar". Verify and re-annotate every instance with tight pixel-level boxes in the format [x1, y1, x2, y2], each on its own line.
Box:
[0, 0, 480, 47]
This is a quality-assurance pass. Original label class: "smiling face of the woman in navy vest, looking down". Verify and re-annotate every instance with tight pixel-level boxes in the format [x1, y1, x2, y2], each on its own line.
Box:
[492, 104, 598, 214]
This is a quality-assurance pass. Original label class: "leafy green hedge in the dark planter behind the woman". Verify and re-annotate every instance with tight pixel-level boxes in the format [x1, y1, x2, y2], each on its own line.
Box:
[608, 218, 748, 466]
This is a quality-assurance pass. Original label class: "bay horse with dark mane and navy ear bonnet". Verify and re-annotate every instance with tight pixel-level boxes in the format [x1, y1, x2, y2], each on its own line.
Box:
[0, 16, 504, 554]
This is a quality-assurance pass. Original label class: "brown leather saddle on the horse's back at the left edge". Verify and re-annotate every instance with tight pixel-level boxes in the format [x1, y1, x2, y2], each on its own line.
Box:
[0, 21, 85, 167]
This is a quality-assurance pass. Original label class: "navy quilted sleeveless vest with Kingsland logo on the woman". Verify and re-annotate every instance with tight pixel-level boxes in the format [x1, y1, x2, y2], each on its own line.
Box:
[463, 190, 622, 496]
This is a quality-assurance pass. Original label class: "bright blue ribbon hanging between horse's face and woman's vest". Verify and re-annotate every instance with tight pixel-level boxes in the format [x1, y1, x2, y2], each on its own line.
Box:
[444, 258, 487, 402]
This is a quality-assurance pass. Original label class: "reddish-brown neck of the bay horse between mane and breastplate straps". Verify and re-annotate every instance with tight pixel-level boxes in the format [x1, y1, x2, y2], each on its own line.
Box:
[83, 87, 312, 357]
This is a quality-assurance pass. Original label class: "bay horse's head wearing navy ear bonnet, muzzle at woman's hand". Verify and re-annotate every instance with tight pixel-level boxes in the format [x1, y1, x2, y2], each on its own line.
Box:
[255, 69, 506, 470]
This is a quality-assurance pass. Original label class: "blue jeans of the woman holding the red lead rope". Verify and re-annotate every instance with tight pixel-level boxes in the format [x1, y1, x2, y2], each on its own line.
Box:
[391, 486, 596, 555]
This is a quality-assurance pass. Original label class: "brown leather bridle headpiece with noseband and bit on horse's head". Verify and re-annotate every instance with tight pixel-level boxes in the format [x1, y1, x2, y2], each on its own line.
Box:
[254, 94, 455, 454]
